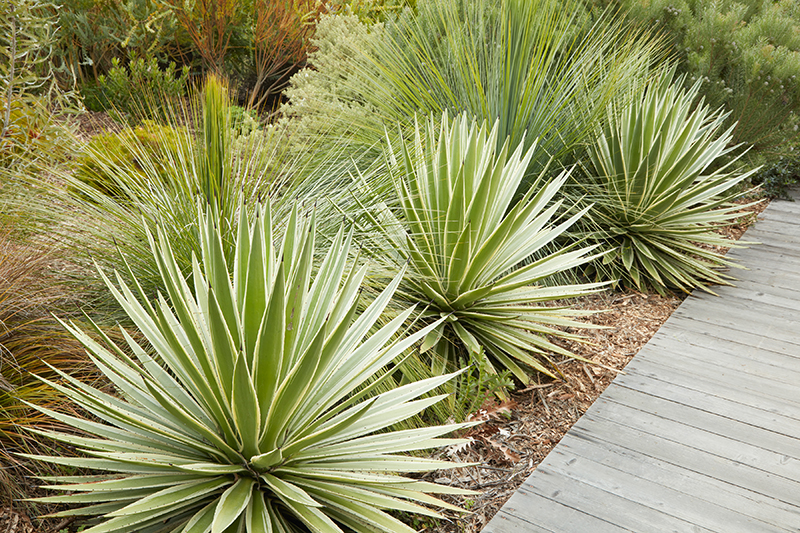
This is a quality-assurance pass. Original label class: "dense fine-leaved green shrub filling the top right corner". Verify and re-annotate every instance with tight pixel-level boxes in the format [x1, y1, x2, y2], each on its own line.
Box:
[592, 0, 800, 158]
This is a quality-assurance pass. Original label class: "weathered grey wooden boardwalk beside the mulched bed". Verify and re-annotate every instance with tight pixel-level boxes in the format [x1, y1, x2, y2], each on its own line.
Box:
[483, 193, 800, 533]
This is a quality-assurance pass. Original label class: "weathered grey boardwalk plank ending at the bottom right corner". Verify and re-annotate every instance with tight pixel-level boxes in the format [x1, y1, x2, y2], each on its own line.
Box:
[548, 433, 798, 533]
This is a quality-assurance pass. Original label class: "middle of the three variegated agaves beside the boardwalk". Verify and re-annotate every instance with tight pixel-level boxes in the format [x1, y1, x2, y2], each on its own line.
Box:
[356, 113, 602, 383]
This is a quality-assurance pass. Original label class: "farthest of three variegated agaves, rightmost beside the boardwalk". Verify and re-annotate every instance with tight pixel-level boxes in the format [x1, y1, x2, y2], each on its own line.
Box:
[575, 70, 755, 292]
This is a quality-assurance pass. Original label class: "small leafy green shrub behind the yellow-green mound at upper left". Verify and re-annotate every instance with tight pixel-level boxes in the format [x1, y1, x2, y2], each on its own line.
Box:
[97, 56, 189, 120]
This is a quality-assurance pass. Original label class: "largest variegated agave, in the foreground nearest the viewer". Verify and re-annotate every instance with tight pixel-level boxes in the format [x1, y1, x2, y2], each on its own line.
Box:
[29, 206, 470, 533]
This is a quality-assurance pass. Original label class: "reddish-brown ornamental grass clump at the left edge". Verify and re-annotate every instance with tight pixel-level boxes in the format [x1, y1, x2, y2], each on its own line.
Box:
[0, 232, 95, 507]
